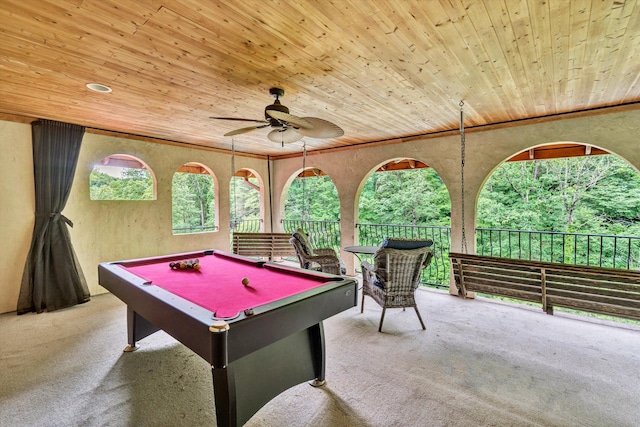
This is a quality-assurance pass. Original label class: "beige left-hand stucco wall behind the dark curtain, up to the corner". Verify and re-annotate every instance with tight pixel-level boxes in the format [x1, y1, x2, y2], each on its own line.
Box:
[0, 122, 268, 312]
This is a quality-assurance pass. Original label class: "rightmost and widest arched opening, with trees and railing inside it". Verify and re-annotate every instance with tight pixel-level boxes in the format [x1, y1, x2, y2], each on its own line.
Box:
[476, 144, 640, 269]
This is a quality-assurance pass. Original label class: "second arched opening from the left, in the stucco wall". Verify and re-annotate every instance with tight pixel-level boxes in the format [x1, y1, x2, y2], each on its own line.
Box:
[171, 163, 218, 234]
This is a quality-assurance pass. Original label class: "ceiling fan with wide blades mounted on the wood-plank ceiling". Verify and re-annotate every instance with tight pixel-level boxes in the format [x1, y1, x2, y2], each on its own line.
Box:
[211, 87, 344, 146]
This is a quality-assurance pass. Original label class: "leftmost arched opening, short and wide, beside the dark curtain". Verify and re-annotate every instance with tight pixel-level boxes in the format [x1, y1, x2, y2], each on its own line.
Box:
[89, 154, 156, 200]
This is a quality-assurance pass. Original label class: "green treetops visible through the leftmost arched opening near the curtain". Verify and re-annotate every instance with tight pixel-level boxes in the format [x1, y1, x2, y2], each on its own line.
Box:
[89, 168, 153, 200]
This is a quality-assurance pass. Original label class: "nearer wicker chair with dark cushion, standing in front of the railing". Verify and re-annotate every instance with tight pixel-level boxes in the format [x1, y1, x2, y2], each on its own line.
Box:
[360, 247, 433, 332]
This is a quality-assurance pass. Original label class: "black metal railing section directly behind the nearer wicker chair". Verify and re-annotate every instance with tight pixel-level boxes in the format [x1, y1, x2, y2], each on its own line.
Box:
[356, 223, 451, 287]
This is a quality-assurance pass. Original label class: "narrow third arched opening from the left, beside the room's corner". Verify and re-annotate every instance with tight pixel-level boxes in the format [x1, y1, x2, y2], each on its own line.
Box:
[229, 169, 264, 233]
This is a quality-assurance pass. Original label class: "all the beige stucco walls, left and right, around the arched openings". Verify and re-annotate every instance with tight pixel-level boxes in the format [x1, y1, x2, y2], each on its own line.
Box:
[0, 110, 640, 312]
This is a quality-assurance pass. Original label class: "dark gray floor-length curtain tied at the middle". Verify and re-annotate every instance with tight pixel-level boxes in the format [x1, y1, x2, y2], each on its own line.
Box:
[17, 120, 90, 314]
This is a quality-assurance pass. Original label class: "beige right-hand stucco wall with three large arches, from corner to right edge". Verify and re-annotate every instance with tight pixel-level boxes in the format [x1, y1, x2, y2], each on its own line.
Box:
[273, 110, 640, 278]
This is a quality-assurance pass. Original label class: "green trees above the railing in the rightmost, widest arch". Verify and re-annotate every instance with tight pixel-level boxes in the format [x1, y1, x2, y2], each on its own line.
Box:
[477, 155, 640, 235]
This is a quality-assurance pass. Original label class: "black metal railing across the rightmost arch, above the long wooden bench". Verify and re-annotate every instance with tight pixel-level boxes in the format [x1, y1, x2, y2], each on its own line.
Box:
[476, 228, 640, 270]
